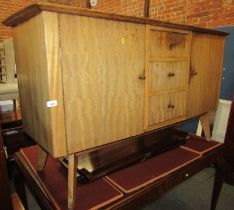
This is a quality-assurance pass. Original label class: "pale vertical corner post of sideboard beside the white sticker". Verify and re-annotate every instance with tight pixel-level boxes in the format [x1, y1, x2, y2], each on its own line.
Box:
[42, 12, 67, 157]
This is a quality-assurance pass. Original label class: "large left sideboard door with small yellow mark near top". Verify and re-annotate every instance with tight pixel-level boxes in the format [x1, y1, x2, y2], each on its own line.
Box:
[59, 15, 145, 153]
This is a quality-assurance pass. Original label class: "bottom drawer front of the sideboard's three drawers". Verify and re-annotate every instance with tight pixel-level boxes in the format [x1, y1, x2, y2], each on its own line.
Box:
[148, 91, 187, 126]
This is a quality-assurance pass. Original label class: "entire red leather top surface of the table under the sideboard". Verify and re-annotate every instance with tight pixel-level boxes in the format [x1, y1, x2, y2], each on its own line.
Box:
[21, 135, 220, 210]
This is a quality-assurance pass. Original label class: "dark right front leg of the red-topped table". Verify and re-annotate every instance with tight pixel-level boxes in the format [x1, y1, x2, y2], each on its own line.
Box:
[210, 165, 223, 210]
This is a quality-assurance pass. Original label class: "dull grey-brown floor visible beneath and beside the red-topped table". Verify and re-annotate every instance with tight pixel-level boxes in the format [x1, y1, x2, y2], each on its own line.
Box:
[20, 168, 234, 210]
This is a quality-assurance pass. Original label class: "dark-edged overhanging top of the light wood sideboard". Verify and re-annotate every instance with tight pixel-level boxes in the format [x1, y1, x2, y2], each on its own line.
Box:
[2, 2, 228, 36]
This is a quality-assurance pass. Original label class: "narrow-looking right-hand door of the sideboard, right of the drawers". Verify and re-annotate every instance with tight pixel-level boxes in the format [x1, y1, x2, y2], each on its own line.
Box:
[188, 33, 224, 117]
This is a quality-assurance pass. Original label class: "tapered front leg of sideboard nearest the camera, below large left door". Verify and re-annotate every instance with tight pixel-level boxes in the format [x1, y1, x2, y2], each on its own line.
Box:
[68, 154, 78, 210]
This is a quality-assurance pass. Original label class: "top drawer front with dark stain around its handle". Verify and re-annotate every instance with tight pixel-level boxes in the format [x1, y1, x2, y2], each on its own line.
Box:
[149, 29, 191, 59]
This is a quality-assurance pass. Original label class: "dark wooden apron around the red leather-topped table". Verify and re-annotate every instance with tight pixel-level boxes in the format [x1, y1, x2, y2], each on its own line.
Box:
[14, 135, 224, 209]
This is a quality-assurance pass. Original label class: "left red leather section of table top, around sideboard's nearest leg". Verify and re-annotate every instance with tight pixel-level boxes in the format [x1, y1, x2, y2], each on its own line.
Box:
[21, 146, 122, 210]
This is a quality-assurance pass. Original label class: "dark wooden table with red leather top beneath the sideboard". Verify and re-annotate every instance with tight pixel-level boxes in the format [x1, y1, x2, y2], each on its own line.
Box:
[12, 135, 223, 210]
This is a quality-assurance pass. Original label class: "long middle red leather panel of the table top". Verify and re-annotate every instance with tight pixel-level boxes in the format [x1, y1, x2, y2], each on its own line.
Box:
[106, 147, 201, 193]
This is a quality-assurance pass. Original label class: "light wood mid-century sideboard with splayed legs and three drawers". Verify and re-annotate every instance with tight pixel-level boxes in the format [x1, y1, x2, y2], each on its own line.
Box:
[4, 3, 227, 208]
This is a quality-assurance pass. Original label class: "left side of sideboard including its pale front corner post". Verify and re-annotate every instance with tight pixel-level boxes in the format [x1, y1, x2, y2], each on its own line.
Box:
[13, 12, 67, 157]
